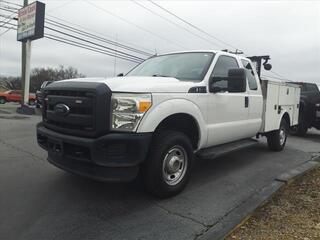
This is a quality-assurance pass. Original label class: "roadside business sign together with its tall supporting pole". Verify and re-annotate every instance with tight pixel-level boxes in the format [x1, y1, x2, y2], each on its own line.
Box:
[17, 0, 45, 111]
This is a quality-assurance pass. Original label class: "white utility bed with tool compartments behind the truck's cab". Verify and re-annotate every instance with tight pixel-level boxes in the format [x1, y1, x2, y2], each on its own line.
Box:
[260, 80, 300, 133]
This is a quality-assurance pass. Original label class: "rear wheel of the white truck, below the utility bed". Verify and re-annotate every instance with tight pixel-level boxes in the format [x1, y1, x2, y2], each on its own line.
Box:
[267, 119, 288, 151]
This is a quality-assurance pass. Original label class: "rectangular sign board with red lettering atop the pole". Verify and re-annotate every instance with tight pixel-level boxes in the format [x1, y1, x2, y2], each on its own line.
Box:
[17, 1, 45, 42]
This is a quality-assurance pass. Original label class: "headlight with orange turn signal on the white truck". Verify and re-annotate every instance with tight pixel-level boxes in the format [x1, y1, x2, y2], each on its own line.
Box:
[111, 93, 152, 131]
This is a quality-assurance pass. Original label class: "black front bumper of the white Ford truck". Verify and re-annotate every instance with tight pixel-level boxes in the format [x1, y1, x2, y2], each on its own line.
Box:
[37, 123, 152, 181]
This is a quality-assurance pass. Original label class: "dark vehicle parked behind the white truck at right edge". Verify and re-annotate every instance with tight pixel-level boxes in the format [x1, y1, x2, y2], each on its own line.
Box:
[293, 82, 320, 136]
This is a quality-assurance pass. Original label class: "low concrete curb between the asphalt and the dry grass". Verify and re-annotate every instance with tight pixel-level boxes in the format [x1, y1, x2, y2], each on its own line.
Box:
[199, 156, 320, 240]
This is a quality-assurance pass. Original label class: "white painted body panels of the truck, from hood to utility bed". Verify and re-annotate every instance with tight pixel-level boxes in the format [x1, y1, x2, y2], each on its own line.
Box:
[59, 50, 300, 150]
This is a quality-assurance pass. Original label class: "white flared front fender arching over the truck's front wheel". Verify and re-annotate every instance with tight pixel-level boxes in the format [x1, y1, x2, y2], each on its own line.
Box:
[137, 99, 208, 149]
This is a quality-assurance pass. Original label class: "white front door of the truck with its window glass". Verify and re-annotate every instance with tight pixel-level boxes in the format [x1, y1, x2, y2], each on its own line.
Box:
[207, 55, 252, 146]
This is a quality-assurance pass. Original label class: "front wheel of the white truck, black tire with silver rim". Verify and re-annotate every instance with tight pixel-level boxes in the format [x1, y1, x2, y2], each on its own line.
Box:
[143, 130, 193, 198]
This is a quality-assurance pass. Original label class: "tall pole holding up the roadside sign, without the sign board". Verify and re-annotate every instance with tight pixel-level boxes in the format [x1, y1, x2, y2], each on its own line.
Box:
[21, 0, 31, 106]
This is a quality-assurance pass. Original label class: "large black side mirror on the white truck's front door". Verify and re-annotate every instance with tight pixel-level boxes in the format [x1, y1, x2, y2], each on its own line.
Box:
[209, 68, 247, 93]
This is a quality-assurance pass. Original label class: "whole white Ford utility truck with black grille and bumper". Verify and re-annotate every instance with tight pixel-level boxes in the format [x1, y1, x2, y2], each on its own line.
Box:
[37, 51, 300, 197]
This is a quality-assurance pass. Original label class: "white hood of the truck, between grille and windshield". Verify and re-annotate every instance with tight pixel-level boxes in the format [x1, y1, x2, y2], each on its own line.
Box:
[60, 77, 195, 93]
